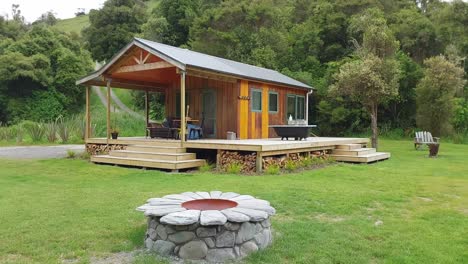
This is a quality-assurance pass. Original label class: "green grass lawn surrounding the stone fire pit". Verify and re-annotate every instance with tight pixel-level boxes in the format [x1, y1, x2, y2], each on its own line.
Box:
[0, 140, 468, 263]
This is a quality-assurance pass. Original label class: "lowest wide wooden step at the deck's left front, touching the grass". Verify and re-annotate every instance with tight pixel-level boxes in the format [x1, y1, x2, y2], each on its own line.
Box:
[91, 155, 205, 170]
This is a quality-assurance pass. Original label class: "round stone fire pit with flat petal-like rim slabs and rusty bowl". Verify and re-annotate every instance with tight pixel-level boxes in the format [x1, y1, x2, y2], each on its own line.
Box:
[137, 191, 275, 262]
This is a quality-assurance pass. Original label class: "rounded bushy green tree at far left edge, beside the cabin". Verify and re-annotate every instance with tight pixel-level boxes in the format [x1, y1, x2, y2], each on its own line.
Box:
[0, 25, 92, 123]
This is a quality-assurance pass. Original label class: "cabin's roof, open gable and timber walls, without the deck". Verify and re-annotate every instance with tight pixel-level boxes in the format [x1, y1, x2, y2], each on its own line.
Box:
[77, 38, 312, 139]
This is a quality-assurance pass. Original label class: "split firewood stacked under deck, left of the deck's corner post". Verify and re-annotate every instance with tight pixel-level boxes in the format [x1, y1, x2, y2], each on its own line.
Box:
[218, 150, 257, 173]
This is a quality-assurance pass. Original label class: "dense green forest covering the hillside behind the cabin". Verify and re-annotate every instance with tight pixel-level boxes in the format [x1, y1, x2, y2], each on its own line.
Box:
[0, 0, 468, 143]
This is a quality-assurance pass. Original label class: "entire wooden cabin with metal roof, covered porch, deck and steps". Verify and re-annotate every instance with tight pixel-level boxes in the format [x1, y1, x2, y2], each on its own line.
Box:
[77, 38, 390, 172]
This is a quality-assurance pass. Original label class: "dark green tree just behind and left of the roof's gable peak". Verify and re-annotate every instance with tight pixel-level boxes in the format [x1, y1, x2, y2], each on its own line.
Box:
[83, 0, 147, 61]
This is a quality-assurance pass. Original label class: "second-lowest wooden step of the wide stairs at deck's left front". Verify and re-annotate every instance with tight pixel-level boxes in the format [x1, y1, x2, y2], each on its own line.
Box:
[109, 150, 197, 161]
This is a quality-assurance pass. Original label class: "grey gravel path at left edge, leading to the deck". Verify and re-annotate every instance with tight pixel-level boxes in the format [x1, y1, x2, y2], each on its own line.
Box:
[0, 145, 84, 159]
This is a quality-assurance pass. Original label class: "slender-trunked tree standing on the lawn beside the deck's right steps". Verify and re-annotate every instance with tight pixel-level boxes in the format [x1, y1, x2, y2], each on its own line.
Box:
[331, 9, 400, 148]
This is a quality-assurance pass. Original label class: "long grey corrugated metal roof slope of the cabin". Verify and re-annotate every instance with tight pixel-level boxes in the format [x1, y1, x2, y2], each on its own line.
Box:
[135, 38, 312, 89]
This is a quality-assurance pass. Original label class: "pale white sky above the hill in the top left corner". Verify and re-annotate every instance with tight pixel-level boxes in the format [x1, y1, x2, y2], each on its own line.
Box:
[0, 0, 105, 22]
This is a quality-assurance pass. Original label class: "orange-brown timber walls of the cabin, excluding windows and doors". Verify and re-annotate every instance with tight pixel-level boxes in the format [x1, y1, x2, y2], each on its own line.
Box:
[156, 71, 307, 139]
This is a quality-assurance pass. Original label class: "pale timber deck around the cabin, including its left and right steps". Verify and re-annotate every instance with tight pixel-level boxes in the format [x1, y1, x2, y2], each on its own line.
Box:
[86, 137, 390, 172]
